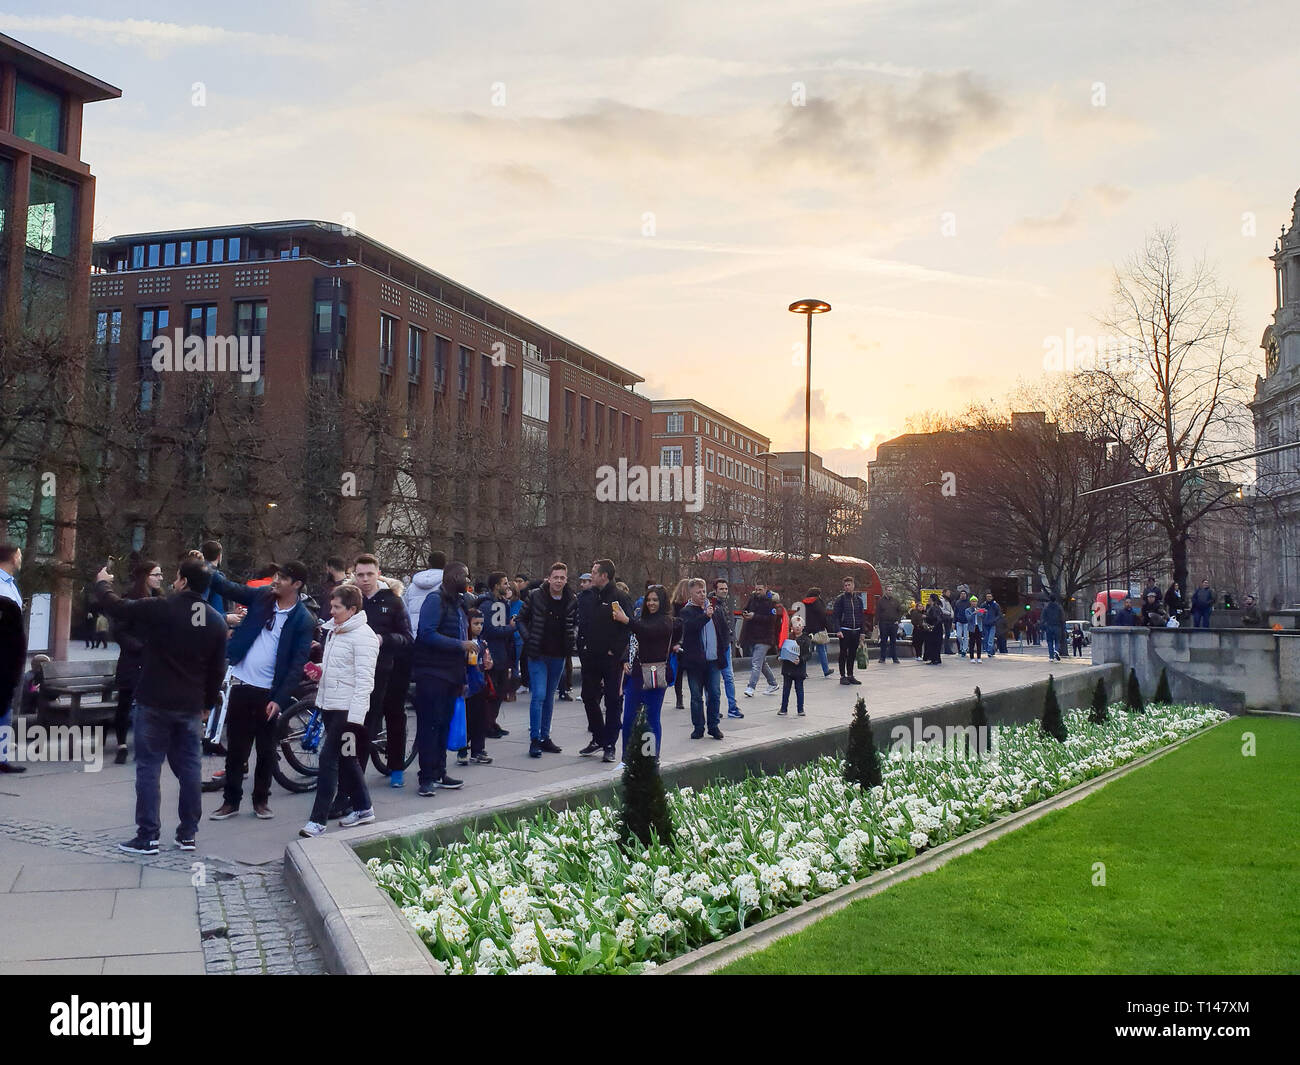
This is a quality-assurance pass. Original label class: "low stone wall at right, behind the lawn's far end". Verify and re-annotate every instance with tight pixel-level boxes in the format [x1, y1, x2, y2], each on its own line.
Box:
[1092, 625, 1300, 713]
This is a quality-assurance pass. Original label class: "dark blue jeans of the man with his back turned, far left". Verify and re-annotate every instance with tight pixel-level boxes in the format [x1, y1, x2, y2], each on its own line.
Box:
[134, 700, 203, 841]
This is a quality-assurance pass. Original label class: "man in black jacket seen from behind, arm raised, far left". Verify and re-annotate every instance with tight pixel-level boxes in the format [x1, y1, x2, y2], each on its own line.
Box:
[95, 558, 226, 854]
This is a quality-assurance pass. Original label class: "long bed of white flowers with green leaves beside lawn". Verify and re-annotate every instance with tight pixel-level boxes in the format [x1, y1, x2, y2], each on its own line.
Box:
[367, 706, 1227, 974]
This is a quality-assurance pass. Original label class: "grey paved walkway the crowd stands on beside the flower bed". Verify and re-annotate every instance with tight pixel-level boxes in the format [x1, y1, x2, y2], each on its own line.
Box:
[0, 653, 1086, 974]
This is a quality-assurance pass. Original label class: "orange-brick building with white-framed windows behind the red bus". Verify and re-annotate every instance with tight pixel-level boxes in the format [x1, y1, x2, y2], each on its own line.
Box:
[650, 399, 771, 560]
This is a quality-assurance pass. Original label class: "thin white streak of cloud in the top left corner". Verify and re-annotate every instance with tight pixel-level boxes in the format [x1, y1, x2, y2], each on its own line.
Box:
[0, 13, 333, 59]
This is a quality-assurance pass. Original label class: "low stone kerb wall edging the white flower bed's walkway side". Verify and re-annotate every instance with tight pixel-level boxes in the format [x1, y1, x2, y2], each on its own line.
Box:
[285, 664, 1125, 974]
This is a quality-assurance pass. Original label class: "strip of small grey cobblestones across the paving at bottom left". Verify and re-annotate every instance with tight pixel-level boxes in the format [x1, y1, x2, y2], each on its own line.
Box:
[0, 818, 325, 975]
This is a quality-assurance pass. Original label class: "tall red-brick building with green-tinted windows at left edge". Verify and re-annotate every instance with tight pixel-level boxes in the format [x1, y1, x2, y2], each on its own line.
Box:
[0, 34, 122, 658]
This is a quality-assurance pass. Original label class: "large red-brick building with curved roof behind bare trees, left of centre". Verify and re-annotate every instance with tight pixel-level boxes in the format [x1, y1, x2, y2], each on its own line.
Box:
[91, 221, 650, 573]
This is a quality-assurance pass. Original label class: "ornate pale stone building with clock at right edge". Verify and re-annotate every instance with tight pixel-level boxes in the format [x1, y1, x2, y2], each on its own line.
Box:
[1249, 191, 1300, 609]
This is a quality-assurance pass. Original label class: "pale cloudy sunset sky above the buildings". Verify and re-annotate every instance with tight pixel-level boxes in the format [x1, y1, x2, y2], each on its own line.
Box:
[0, 0, 1300, 476]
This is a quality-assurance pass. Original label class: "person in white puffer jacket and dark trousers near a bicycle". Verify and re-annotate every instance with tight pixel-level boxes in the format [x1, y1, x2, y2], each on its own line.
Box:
[298, 584, 380, 837]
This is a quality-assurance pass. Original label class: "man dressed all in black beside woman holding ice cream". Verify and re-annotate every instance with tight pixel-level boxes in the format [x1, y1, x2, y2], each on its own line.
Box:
[577, 558, 632, 762]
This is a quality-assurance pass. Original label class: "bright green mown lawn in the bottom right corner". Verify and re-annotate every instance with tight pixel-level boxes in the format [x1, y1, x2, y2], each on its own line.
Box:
[723, 718, 1300, 974]
